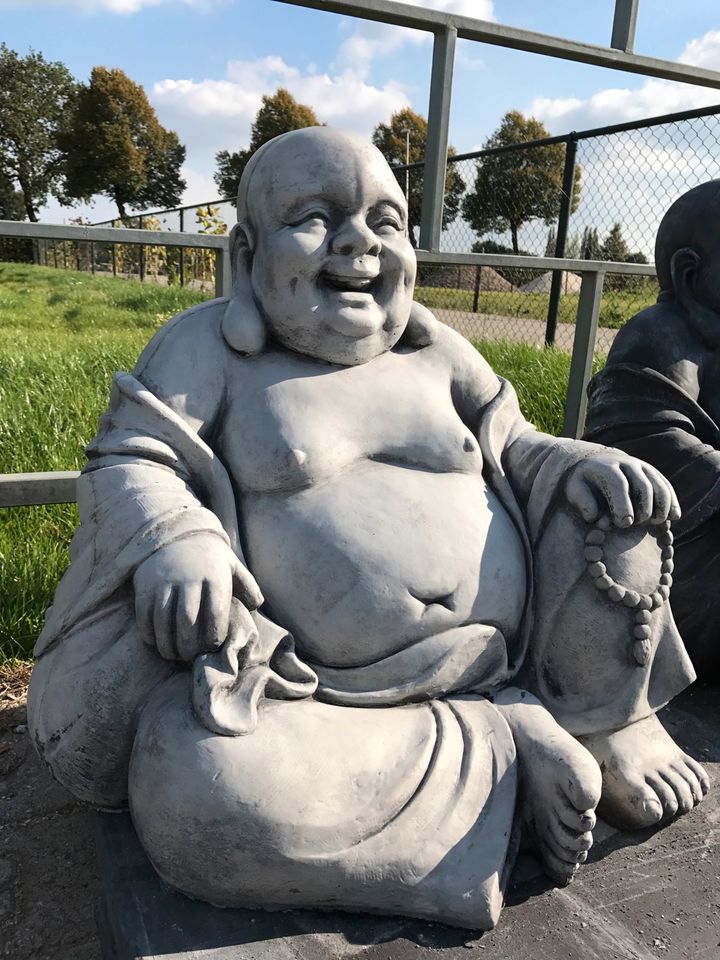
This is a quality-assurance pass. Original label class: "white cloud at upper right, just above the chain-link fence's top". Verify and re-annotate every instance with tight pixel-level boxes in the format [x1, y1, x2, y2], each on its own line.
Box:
[528, 30, 720, 132]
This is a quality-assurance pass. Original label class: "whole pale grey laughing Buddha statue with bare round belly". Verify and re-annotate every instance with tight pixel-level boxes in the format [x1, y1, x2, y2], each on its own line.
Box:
[29, 128, 708, 929]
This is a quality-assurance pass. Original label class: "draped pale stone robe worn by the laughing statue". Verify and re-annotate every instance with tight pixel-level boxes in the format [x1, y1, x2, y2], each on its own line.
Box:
[29, 301, 693, 928]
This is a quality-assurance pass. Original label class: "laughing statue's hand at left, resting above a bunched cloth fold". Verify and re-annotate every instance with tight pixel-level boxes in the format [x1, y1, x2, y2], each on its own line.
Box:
[133, 534, 263, 662]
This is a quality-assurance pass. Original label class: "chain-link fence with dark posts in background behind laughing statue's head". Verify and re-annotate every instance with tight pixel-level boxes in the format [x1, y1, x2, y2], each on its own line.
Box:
[31, 106, 720, 350]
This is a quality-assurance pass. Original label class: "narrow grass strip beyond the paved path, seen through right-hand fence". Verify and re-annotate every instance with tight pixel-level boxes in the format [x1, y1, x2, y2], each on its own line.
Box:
[415, 283, 658, 329]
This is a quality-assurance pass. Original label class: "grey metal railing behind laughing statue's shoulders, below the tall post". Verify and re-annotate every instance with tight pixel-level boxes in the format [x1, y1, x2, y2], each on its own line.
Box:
[0, 220, 654, 507]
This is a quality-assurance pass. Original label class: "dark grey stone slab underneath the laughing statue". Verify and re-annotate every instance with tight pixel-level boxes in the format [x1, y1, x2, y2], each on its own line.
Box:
[97, 688, 720, 960]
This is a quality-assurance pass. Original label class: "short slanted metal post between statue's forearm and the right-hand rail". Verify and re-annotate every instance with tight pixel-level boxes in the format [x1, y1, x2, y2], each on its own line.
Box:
[562, 271, 605, 438]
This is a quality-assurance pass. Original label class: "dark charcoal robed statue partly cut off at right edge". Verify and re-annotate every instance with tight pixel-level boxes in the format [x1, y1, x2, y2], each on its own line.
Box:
[586, 180, 720, 682]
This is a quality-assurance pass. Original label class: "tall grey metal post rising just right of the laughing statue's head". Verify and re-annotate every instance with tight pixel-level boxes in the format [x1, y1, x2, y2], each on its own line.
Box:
[419, 26, 457, 251]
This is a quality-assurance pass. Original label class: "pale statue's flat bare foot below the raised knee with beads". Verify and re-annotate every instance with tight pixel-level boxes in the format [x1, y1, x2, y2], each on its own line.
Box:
[580, 713, 710, 830]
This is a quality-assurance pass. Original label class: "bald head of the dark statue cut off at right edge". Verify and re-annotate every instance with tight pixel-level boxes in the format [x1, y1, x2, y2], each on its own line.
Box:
[655, 180, 720, 290]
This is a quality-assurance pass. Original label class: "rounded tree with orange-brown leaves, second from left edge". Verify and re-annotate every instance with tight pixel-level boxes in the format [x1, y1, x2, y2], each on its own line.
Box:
[60, 67, 185, 220]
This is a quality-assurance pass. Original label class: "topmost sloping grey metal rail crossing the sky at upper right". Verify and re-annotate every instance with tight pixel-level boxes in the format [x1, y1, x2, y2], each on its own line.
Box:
[276, 0, 720, 90]
